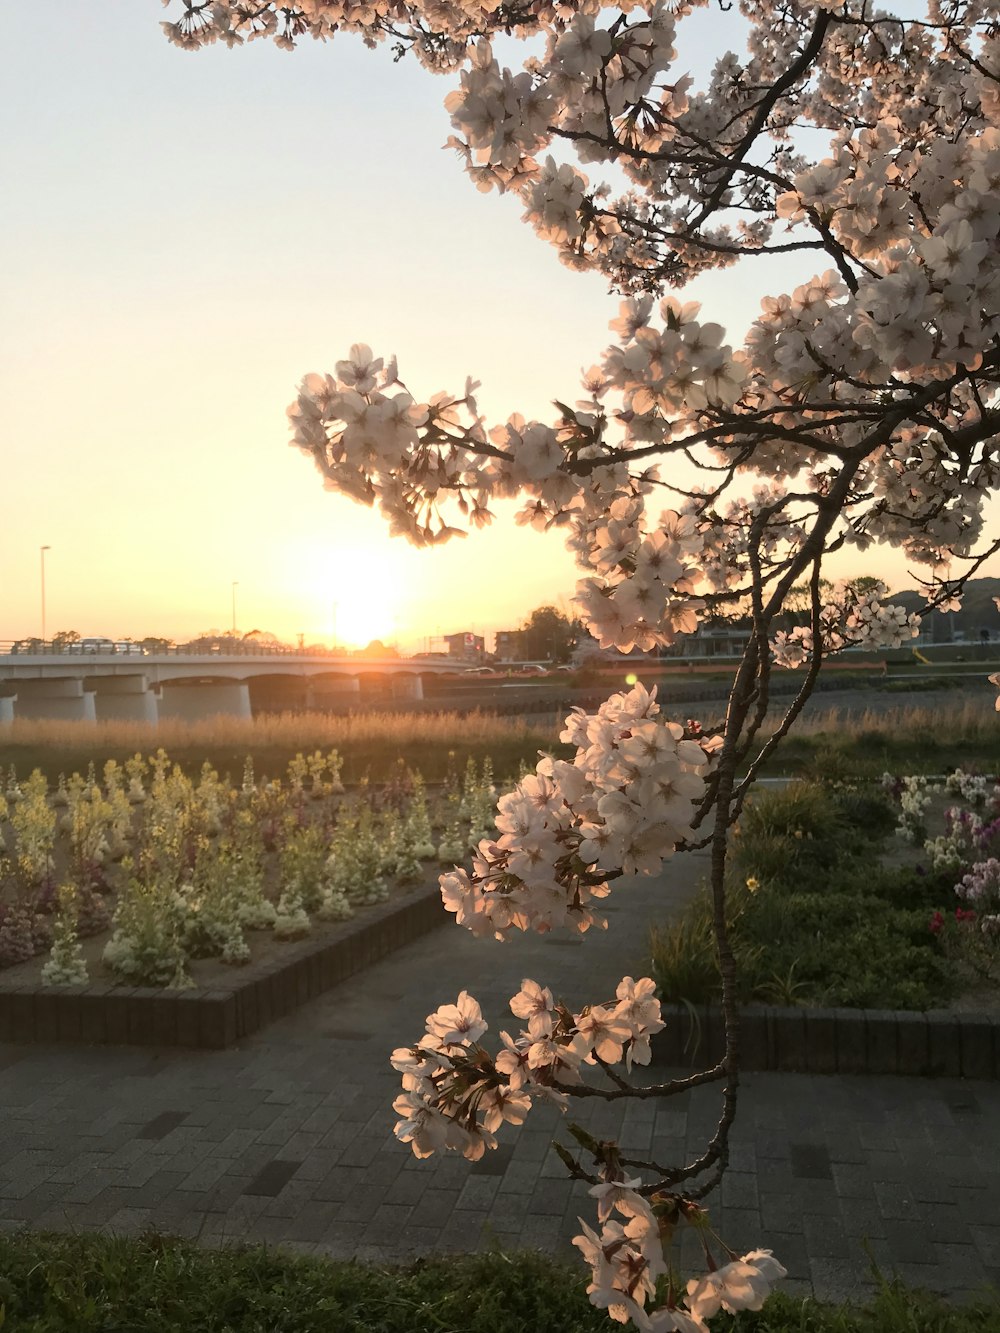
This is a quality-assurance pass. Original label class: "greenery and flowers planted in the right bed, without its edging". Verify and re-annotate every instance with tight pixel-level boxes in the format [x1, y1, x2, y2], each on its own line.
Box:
[653, 774, 997, 1018]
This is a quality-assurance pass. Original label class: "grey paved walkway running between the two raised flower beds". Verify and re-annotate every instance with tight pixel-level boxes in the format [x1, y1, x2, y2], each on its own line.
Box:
[0, 858, 1000, 1300]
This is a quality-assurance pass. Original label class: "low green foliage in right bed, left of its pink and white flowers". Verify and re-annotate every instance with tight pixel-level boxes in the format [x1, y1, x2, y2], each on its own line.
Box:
[652, 782, 953, 1009]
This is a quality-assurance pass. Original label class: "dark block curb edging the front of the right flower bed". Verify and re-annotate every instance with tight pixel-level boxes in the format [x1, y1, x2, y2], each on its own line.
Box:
[652, 1005, 1000, 1080]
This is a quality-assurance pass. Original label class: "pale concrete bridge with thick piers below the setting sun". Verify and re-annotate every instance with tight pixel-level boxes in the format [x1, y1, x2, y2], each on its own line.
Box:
[0, 645, 456, 724]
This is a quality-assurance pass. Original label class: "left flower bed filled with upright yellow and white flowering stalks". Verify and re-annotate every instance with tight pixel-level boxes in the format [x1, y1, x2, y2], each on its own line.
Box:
[0, 750, 504, 1023]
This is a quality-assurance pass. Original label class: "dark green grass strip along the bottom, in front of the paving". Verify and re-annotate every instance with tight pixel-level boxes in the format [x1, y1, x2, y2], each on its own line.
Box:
[0, 1232, 1000, 1333]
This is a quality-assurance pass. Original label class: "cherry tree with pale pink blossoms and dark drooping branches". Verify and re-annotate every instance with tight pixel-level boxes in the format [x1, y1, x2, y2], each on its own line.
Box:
[164, 0, 1000, 1333]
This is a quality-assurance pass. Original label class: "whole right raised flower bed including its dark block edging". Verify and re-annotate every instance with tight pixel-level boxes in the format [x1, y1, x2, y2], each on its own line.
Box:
[653, 778, 1000, 1078]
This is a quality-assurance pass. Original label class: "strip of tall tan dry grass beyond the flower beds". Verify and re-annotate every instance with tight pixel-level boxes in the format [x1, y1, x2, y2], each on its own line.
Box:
[0, 689, 1000, 782]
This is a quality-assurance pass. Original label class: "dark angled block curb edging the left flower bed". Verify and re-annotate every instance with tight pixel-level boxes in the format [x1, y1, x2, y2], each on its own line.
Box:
[0, 884, 449, 1050]
